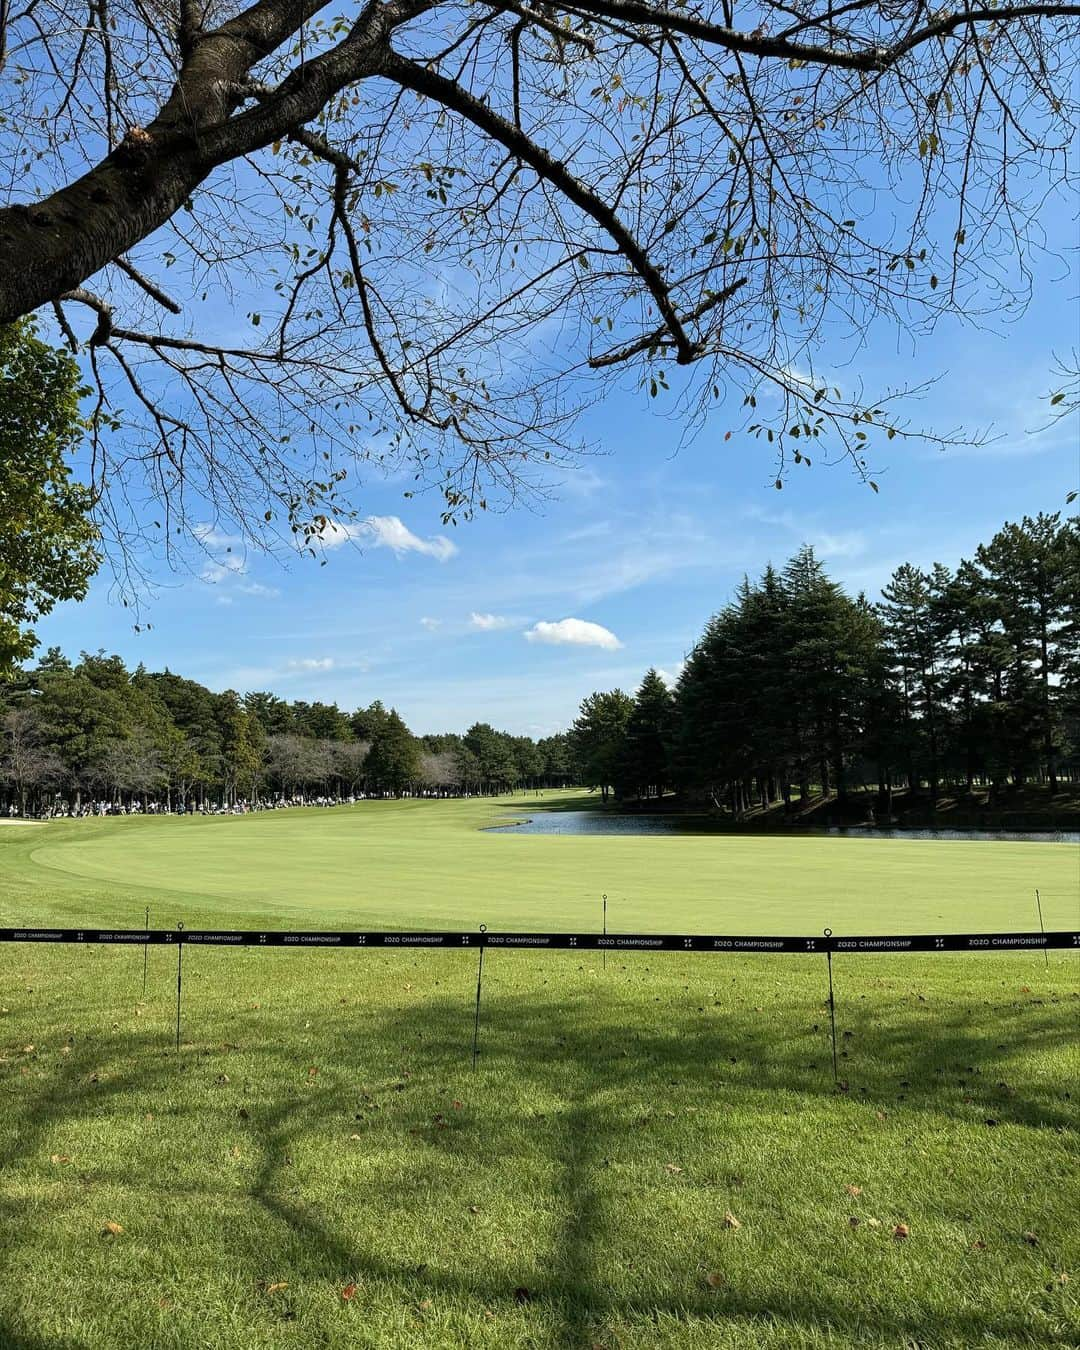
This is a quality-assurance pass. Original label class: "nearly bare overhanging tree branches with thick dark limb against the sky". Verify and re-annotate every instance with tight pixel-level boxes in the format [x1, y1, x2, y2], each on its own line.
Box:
[0, 0, 1080, 558]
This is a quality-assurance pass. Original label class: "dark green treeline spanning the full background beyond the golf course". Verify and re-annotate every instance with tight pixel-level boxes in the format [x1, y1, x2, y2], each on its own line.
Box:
[0, 514, 1080, 817]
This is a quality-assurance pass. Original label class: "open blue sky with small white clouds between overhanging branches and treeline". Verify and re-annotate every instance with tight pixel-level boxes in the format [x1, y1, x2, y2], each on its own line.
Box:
[38, 212, 1080, 736]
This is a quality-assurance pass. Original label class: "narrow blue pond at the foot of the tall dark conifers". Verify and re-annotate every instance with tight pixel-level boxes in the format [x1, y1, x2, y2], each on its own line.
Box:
[490, 811, 1080, 844]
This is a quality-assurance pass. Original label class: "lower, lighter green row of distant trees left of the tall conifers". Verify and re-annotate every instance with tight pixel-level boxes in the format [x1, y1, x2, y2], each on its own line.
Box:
[0, 648, 574, 814]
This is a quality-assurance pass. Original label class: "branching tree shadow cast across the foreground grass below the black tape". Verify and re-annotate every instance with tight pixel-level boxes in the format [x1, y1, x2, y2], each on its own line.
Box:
[0, 955, 1080, 1350]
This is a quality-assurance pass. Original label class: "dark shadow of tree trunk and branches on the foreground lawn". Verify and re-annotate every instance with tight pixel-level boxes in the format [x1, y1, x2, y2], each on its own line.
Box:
[0, 963, 1080, 1350]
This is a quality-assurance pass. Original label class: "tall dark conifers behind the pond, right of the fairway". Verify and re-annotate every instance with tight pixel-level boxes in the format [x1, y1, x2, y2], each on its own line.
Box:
[571, 514, 1080, 814]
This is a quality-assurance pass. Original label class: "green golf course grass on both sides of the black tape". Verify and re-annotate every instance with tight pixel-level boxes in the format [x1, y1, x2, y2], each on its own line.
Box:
[0, 801, 1080, 1350]
